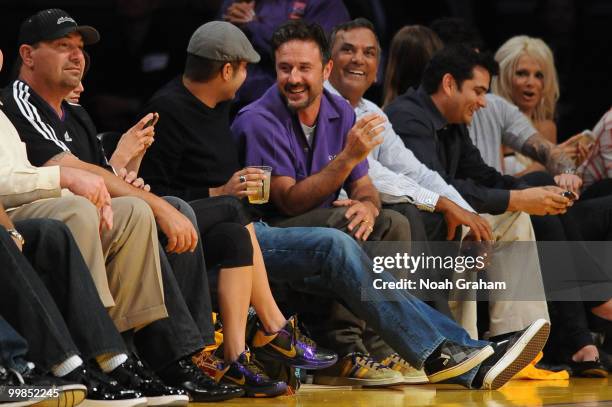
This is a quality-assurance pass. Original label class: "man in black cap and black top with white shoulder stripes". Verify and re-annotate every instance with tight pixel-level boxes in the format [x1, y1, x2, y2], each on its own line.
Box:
[2, 9, 242, 401]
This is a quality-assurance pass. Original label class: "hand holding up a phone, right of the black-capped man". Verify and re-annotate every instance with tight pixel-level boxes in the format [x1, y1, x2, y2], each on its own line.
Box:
[109, 113, 159, 168]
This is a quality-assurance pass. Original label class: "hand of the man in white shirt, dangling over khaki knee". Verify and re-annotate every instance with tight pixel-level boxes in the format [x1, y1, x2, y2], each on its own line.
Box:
[436, 196, 493, 242]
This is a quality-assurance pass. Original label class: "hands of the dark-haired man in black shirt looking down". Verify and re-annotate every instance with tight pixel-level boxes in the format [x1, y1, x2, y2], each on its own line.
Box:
[508, 186, 572, 216]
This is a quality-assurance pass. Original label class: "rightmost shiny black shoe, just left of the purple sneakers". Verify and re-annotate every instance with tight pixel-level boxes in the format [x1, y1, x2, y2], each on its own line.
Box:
[158, 357, 244, 403]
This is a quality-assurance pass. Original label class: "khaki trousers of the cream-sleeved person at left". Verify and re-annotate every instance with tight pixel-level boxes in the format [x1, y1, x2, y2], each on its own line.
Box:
[9, 196, 168, 332]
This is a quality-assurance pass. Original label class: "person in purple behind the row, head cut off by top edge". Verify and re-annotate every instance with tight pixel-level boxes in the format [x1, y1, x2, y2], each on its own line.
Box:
[220, 0, 349, 106]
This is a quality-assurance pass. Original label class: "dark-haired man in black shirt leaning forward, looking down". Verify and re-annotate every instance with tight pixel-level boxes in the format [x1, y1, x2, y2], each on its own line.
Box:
[385, 46, 571, 215]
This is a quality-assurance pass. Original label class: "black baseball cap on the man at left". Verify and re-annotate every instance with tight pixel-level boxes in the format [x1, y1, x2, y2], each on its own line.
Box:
[19, 8, 100, 45]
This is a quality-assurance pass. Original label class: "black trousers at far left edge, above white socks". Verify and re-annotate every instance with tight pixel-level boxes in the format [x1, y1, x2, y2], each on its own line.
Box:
[0, 219, 125, 369]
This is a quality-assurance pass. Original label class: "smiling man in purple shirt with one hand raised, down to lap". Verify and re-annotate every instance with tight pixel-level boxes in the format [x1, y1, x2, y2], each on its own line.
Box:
[232, 22, 410, 244]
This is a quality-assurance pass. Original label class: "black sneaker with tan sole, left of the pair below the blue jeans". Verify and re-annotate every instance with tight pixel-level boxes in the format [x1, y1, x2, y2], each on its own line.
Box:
[424, 340, 493, 383]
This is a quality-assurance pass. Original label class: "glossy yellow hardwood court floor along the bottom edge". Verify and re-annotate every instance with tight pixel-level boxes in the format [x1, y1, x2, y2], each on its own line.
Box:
[190, 379, 612, 407]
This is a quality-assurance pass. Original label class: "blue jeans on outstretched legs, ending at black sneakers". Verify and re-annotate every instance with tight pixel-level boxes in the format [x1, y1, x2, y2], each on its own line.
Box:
[255, 222, 488, 387]
